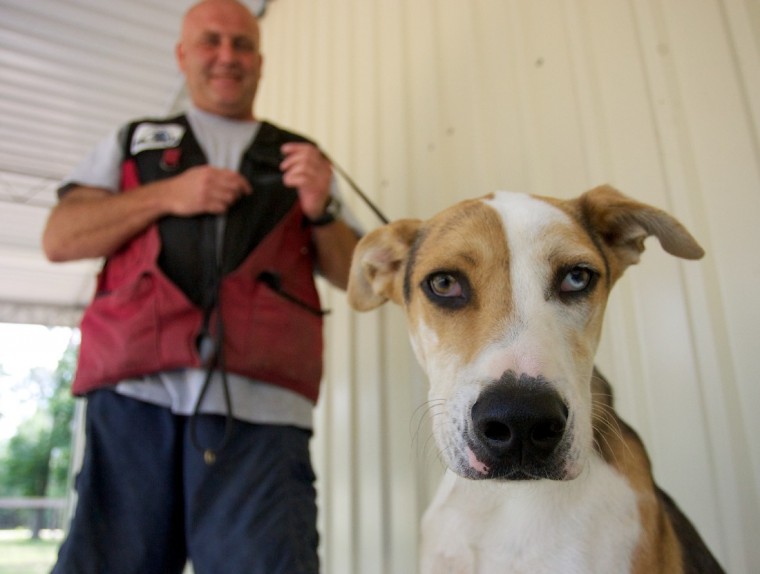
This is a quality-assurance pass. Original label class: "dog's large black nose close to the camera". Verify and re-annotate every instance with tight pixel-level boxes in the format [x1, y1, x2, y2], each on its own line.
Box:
[472, 376, 567, 467]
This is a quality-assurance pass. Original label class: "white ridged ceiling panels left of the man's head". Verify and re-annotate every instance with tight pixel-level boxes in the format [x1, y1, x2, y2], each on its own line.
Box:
[0, 0, 205, 323]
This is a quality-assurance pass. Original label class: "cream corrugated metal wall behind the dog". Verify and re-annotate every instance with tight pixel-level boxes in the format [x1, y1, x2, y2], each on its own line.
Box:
[257, 0, 760, 574]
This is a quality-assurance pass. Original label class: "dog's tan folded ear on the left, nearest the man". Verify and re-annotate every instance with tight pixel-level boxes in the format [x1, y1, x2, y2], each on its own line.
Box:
[348, 219, 422, 311]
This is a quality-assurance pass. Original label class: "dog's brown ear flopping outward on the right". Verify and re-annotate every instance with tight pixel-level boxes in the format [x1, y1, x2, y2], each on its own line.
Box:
[578, 185, 705, 272]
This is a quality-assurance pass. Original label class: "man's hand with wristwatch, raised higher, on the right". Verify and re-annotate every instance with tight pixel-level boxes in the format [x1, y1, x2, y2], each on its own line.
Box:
[280, 143, 332, 219]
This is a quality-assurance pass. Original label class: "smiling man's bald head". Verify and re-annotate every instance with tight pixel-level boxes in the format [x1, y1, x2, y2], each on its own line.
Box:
[176, 0, 262, 119]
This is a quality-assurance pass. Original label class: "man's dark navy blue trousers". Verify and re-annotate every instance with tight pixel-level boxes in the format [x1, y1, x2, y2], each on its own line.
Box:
[53, 390, 319, 574]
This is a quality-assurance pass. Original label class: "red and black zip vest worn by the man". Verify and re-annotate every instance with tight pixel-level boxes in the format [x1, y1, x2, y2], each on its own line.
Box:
[73, 116, 323, 402]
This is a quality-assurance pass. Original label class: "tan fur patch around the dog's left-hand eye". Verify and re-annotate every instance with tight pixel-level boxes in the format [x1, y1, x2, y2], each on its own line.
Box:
[407, 200, 512, 368]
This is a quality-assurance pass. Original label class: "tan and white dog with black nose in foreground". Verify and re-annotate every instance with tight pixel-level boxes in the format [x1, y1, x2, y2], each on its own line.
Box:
[348, 186, 723, 574]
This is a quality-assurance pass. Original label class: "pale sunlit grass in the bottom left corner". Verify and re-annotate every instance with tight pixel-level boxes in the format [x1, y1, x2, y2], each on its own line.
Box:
[0, 529, 61, 574]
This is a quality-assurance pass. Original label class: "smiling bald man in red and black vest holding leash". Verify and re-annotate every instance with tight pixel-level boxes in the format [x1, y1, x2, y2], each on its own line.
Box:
[43, 0, 357, 574]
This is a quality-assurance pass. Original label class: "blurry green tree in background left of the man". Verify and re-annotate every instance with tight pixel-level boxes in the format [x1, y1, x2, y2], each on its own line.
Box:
[0, 344, 78, 538]
